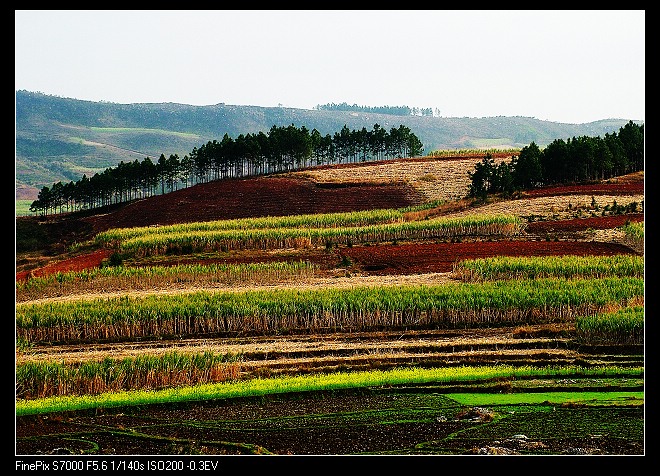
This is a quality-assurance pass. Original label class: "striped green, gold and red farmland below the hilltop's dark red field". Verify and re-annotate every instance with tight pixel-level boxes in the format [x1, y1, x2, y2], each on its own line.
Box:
[15, 153, 645, 458]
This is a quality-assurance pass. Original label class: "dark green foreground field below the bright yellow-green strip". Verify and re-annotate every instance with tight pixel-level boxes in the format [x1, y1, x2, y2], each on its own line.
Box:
[17, 377, 644, 455]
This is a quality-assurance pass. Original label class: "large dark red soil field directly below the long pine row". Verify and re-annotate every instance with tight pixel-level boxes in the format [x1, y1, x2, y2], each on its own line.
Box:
[84, 176, 422, 233]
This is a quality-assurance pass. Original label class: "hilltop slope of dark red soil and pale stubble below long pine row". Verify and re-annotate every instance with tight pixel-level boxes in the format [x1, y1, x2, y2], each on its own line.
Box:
[16, 153, 508, 263]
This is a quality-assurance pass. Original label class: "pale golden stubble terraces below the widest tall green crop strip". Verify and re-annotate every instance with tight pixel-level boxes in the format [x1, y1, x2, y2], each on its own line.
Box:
[16, 324, 577, 371]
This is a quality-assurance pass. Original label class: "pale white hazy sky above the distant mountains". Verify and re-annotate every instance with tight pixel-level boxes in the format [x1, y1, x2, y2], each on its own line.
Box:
[15, 10, 645, 123]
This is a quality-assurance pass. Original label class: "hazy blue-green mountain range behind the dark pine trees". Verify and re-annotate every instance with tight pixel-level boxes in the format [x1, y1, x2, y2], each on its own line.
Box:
[16, 91, 637, 200]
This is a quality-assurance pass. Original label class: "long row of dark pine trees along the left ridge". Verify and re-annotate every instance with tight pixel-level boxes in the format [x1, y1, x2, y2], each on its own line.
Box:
[30, 124, 424, 215]
